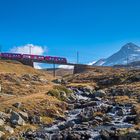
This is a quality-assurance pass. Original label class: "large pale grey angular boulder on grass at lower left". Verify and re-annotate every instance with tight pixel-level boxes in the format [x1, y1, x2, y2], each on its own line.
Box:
[10, 111, 25, 126]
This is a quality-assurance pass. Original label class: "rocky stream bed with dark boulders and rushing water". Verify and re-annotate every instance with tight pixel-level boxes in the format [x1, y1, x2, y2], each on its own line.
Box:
[23, 88, 139, 140]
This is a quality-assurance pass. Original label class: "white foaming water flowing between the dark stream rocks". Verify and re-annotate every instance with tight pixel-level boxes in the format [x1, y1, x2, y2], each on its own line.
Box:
[40, 89, 133, 140]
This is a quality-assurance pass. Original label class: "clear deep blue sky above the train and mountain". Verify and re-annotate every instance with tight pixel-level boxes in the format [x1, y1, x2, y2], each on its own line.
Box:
[0, 0, 140, 63]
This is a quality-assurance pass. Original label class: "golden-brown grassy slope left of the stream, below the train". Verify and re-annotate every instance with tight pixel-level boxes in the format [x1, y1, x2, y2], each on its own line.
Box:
[0, 60, 66, 139]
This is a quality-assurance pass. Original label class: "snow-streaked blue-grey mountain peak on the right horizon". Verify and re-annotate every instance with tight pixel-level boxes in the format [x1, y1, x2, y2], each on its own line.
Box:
[94, 43, 140, 66]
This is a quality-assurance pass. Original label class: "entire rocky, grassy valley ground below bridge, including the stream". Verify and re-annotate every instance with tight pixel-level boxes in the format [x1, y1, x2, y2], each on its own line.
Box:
[0, 61, 140, 140]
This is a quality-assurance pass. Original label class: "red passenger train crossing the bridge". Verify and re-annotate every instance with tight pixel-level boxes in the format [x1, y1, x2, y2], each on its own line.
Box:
[0, 53, 67, 64]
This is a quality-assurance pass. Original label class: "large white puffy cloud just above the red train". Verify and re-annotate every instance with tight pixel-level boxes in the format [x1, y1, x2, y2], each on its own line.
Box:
[10, 44, 46, 55]
